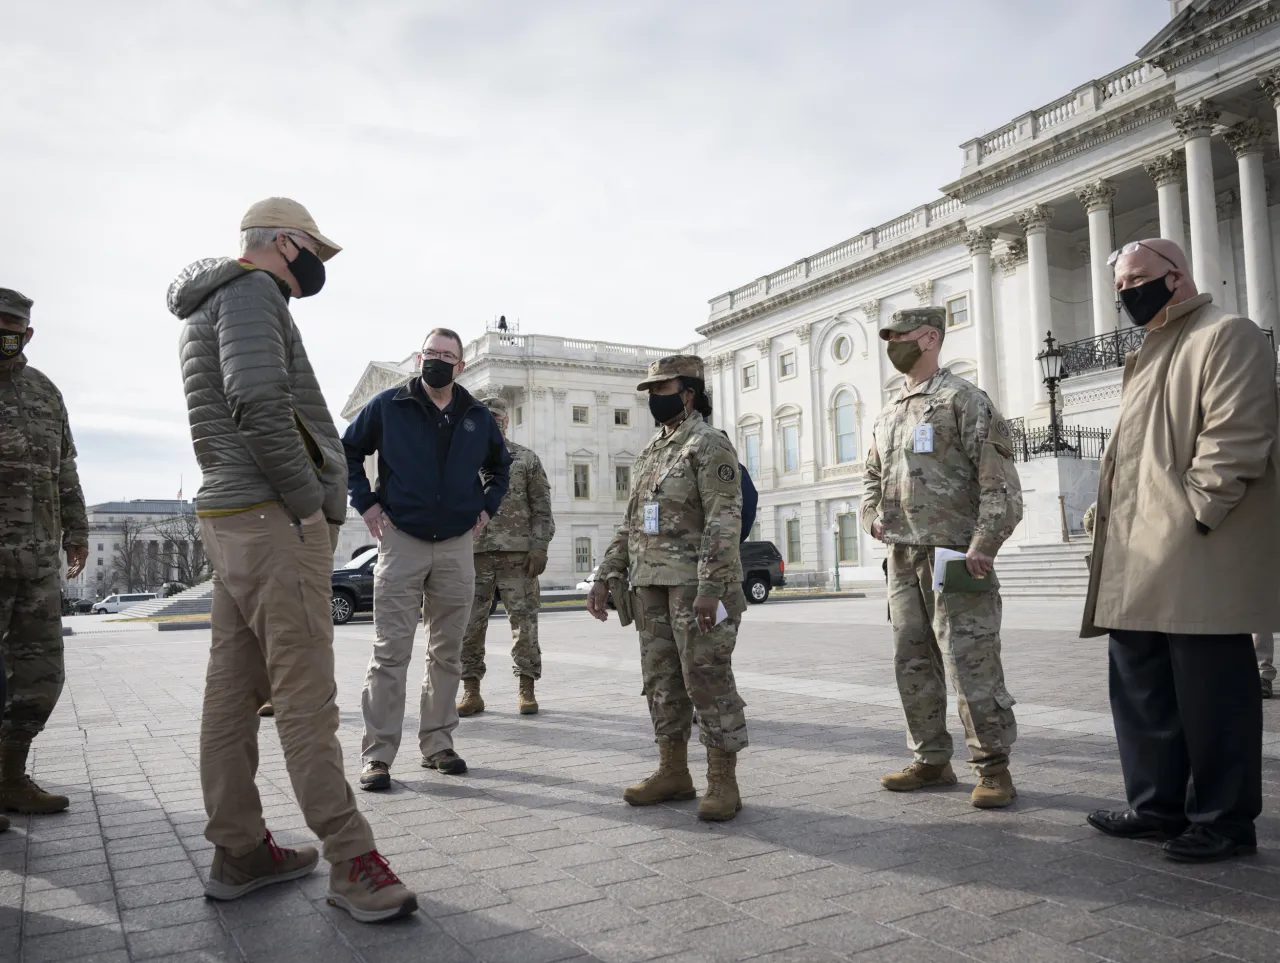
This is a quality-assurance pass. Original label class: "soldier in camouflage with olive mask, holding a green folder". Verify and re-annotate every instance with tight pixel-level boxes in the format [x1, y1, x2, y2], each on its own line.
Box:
[863, 307, 1023, 809]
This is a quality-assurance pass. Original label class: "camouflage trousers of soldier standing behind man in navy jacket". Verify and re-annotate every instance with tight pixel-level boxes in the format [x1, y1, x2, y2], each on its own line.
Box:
[462, 552, 543, 679]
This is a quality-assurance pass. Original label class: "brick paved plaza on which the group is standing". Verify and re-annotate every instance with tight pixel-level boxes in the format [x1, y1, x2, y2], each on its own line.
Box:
[0, 598, 1280, 963]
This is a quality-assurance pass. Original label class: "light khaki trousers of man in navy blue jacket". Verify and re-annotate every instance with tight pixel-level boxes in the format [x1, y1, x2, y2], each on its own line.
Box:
[361, 528, 476, 766]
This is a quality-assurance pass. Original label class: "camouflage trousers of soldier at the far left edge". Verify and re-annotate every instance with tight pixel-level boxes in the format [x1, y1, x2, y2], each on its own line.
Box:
[0, 571, 64, 749]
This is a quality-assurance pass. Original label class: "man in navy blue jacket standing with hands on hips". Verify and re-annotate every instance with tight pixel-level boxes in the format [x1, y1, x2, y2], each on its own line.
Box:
[342, 328, 511, 790]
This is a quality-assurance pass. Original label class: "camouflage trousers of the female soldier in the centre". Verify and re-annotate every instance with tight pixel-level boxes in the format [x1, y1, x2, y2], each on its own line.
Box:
[636, 585, 748, 753]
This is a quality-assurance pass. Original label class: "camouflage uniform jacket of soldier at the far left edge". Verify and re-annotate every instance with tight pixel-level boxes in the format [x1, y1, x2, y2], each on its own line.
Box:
[0, 356, 88, 579]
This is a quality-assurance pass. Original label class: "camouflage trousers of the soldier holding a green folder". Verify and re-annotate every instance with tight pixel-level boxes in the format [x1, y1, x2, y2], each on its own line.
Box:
[888, 544, 1018, 776]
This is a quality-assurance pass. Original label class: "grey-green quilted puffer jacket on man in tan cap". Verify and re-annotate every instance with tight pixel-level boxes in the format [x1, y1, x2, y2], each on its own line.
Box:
[169, 257, 347, 524]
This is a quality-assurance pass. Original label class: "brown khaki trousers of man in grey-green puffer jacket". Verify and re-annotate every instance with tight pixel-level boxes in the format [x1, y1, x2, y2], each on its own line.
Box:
[200, 503, 375, 863]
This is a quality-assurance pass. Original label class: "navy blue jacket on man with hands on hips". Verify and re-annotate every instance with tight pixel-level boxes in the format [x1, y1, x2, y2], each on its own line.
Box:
[342, 378, 511, 542]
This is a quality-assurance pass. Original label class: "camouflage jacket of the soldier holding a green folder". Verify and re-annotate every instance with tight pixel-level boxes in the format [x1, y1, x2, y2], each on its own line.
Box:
[863, 368, 1023, 556]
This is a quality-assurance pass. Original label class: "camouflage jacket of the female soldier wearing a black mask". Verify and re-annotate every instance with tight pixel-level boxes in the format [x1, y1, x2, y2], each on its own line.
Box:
[596, 412, 742, 598]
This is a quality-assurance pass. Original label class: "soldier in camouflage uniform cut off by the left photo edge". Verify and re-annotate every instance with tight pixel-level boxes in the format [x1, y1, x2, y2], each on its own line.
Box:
[0, 288, 88, 826]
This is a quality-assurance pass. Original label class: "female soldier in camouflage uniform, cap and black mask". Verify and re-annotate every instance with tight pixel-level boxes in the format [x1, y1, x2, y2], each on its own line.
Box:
[588, 355, 746, 821]
